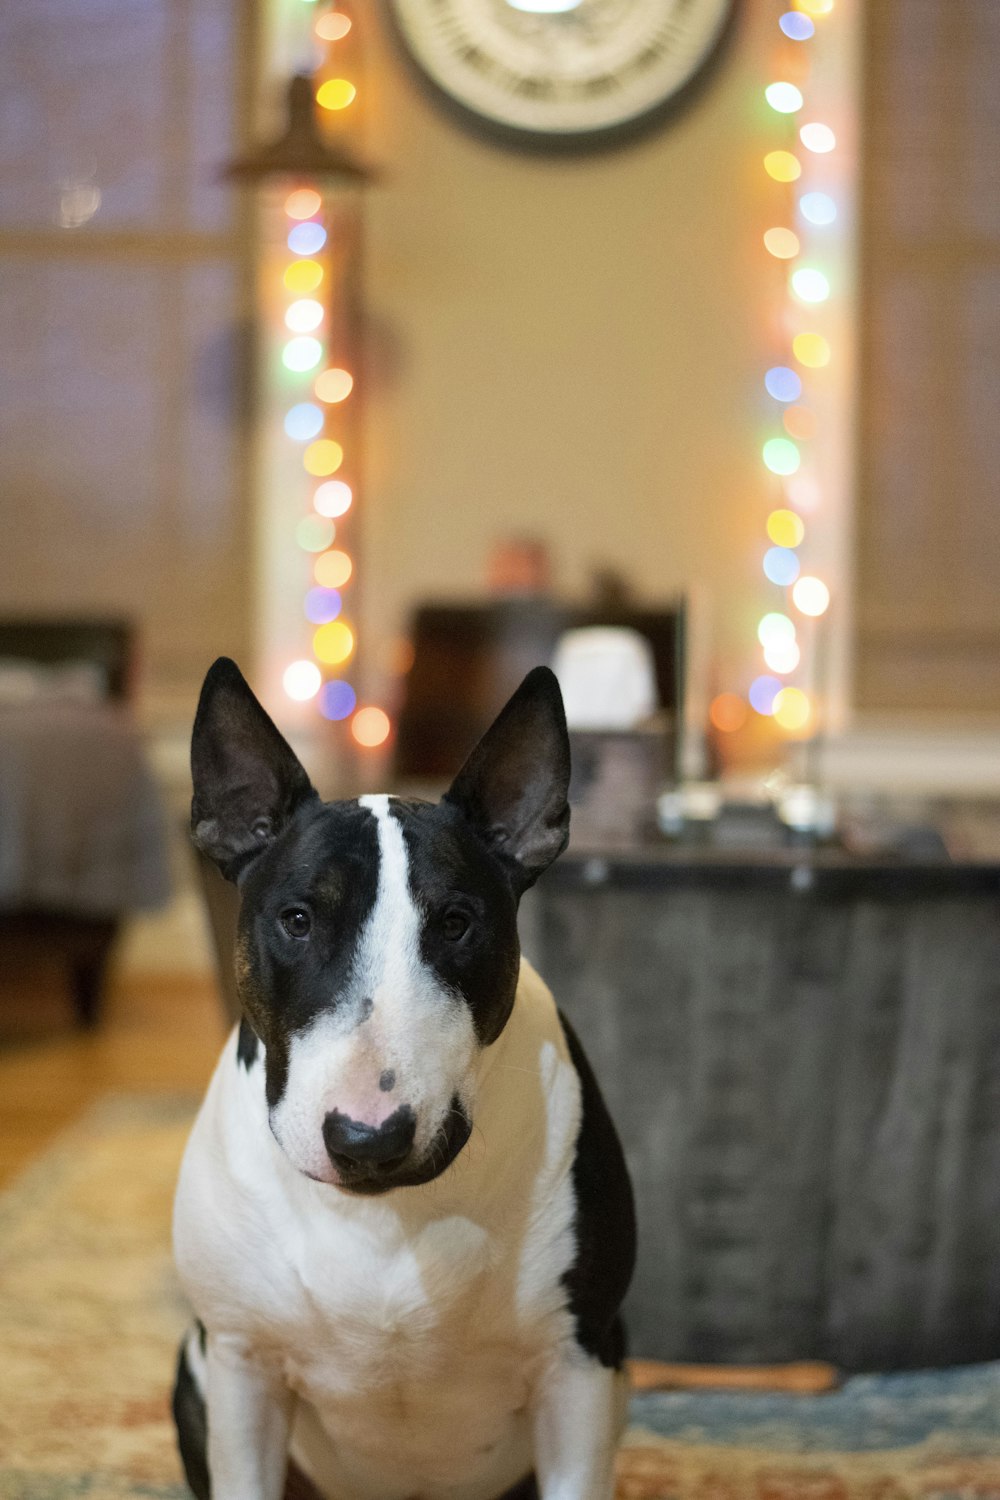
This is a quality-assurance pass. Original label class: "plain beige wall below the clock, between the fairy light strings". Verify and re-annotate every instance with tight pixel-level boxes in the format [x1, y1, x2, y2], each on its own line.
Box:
[363, 0, 783, 708]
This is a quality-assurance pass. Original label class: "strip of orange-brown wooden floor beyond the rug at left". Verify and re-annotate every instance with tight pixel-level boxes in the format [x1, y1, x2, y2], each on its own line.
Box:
[0, 962, 225, 1185]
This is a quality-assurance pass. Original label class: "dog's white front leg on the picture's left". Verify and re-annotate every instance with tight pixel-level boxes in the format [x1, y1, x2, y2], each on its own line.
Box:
[205, 1335, 294, 1500]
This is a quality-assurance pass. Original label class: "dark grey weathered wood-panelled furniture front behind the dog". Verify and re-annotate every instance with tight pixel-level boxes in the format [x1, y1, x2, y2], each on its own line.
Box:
[523, 843, 1000, 1370]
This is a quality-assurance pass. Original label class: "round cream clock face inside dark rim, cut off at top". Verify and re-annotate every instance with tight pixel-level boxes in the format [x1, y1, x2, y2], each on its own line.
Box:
[391, 0, 733, 141]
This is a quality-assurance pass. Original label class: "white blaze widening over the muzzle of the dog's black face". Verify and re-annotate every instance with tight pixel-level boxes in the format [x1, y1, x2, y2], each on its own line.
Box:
[271, 797, 480, 1182]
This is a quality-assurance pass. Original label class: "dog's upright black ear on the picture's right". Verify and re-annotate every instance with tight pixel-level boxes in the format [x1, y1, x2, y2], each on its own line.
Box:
[444, 666, 570, 891]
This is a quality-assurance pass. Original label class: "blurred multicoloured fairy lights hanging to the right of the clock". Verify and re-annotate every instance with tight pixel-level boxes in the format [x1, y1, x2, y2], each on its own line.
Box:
[711, 0, 838, 735]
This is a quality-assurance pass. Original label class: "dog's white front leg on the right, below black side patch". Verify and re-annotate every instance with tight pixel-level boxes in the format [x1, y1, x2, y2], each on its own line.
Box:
[534, 1346, 628, 1500]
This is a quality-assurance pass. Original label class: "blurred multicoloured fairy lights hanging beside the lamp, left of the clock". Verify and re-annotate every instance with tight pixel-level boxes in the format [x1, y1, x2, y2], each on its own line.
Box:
[282, 0, 391, 749]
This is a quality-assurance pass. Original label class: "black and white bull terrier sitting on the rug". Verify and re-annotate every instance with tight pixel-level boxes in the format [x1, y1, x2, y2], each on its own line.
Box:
[174, 659, 634, 1500]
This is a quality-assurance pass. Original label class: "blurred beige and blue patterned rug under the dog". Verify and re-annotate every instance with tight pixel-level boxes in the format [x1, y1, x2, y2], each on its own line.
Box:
[0, 1097, 1000, 1500]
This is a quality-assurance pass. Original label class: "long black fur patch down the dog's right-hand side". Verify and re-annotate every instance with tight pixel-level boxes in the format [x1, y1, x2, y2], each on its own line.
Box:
[559, 1013, 636, 1370]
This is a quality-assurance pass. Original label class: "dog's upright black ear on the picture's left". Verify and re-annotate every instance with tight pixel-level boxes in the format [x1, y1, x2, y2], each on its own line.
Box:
[190, 657, 318, 881]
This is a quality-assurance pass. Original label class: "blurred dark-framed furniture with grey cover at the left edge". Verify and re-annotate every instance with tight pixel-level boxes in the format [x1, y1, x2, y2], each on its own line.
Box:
[0, 620, 169, 1025]
